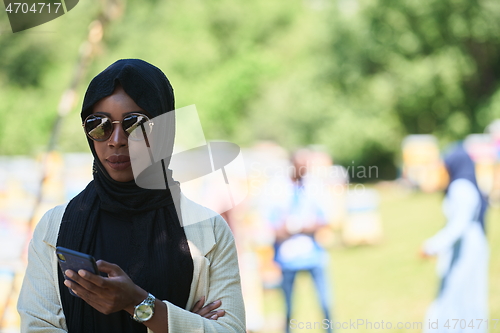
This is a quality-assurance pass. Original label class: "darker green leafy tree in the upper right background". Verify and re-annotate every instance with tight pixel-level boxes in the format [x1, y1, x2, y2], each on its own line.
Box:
[328, 0, 500, 140]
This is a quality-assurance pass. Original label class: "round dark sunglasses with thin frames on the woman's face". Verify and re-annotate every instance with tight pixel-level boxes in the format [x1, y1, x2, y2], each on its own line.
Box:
[82, 113, 153, 142]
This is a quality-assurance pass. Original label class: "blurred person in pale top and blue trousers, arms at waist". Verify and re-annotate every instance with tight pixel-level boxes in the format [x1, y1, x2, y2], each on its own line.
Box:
[269, 149, 331, 332]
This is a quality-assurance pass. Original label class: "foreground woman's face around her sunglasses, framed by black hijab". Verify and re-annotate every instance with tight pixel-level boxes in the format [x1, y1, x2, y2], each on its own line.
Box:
[92, 87, 146, 182]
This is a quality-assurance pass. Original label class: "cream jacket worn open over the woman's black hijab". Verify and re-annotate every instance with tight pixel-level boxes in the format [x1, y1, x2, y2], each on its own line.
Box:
[17, 198, 245, 333]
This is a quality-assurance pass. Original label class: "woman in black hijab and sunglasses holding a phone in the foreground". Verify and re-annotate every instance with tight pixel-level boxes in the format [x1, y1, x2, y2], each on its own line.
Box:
[18, 59, 245, 333]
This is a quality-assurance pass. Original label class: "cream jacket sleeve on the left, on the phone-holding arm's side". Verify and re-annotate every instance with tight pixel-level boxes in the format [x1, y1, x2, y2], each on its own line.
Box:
[17, 207, 67, 333]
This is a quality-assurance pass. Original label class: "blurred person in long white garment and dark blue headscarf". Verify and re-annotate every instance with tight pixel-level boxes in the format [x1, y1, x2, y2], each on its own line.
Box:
[422, 145, 489, 333]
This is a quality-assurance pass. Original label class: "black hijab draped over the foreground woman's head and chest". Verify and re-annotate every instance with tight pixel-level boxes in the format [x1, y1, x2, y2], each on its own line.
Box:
[57, 59, 193, 333]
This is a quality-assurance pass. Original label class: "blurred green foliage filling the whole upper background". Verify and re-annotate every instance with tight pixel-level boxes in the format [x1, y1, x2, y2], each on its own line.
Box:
[0, 0, 500, 178]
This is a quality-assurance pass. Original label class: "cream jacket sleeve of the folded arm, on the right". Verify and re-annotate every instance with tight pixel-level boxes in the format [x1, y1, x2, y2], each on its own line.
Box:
[160, 216, 246, 333]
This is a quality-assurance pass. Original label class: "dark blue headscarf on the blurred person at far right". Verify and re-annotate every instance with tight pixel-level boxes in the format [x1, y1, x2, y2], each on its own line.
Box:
[444, 144, 488, 231]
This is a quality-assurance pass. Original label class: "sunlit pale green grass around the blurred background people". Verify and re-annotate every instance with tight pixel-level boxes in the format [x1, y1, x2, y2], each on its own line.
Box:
[262, 187, 500, 333]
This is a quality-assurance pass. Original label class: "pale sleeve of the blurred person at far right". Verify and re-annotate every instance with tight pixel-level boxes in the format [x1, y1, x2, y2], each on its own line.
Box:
[424, 179, 481, 255]
